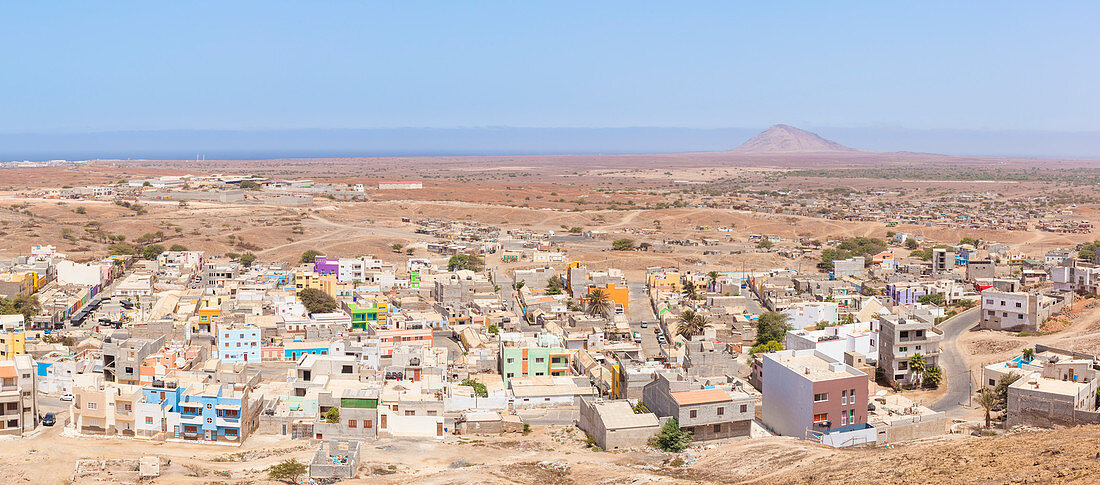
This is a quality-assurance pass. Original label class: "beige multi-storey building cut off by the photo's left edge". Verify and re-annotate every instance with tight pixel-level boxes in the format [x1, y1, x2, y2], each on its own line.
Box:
[0, 354, 39, 436]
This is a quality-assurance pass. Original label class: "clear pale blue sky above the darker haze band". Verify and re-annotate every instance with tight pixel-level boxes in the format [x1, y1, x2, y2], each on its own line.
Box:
[0, 0, 1100, 133]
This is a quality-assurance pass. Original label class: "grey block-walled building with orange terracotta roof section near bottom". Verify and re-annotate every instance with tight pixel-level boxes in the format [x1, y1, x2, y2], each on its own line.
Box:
[641, 375, 756, 441]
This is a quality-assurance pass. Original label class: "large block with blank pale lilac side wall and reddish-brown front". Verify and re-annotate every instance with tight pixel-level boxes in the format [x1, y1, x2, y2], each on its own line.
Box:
[760, 350, 875, 445]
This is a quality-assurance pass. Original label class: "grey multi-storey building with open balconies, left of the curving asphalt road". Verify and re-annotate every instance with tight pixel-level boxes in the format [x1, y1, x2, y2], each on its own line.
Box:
[877, 315, 944, 386]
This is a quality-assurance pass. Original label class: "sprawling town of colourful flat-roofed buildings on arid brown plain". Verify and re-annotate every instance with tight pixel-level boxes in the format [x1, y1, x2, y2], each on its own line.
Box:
[0, 166, 1100, 480]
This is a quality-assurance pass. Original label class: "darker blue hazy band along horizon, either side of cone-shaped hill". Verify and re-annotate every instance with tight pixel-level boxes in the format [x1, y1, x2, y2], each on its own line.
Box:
[0, 126, 1100, 162]
